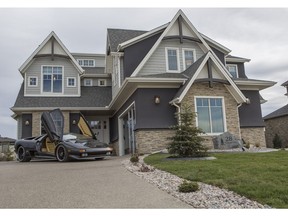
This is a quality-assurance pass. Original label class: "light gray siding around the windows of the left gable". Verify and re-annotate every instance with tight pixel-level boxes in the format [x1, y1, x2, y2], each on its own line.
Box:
[25, 57, 79, 95]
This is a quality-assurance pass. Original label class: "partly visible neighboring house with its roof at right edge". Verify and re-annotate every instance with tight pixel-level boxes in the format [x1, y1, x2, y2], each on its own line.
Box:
[264, 81, 288, 148]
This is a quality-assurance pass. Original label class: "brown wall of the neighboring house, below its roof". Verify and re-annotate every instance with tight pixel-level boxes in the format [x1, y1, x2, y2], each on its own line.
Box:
[265, 116, 288, 148]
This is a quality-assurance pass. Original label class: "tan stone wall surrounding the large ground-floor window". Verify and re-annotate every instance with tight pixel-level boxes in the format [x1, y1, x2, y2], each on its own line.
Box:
[182, 83, 241, 148]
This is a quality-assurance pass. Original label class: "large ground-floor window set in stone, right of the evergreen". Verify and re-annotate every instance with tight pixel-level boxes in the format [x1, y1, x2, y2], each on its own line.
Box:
[196, 97, 225, 134]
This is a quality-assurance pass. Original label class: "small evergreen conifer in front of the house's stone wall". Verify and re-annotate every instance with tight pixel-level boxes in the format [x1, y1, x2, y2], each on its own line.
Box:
[168, 105, 207, 157]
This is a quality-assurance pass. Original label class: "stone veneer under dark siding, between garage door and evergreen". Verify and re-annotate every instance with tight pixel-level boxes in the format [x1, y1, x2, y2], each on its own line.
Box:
[135, 129, 174, 154]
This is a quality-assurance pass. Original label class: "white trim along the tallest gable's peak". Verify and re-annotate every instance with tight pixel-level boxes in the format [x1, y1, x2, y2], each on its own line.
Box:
[131, 10, 212, 77]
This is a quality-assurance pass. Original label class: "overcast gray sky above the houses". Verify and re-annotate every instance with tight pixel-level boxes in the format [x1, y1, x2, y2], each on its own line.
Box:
[0, 8, 288, 138]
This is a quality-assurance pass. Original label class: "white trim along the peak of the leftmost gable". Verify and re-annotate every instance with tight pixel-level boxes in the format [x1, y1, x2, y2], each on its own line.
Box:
[19, 31, 84, 74]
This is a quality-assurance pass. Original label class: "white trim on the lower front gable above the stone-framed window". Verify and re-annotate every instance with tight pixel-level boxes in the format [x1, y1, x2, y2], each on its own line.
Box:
[177, 52, 247, 104]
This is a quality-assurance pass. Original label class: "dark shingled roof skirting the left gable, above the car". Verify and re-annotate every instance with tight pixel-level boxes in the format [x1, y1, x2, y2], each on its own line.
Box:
[11, 84, 112, 110]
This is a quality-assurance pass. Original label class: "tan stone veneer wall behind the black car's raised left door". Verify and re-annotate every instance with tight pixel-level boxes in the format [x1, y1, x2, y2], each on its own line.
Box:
[32, 112, 69, 136]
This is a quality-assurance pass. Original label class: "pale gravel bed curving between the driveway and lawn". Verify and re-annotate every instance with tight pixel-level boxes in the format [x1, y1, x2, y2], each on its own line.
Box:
[122, 150, 270, 209]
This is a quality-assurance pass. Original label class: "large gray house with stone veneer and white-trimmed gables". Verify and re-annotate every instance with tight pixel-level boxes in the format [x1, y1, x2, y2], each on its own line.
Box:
[11, 10, 275, 155]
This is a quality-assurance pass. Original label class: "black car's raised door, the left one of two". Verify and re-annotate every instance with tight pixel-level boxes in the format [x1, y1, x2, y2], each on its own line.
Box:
[41, 109, 64, 142]
